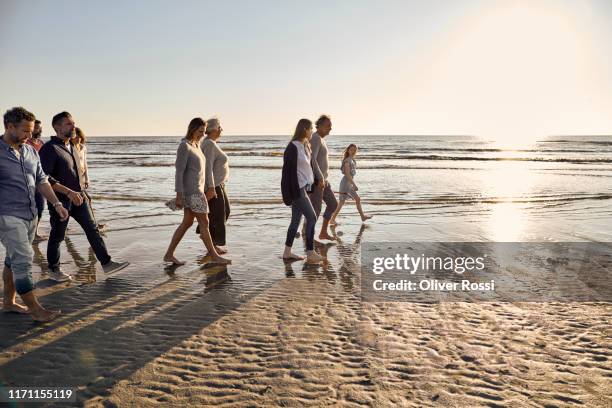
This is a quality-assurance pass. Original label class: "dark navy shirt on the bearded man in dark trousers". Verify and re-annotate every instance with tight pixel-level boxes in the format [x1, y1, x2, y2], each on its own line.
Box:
[38, 136, 81, 191]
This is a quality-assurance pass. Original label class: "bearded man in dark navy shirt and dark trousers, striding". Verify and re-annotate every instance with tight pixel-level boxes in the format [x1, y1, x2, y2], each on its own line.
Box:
[40, 112, 129, 279]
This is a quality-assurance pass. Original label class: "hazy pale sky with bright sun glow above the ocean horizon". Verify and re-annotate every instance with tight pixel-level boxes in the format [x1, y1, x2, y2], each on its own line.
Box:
[0, 0, 612, 138]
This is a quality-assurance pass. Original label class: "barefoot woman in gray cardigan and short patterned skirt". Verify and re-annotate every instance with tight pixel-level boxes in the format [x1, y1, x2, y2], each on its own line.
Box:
[164, 118, 231, 265]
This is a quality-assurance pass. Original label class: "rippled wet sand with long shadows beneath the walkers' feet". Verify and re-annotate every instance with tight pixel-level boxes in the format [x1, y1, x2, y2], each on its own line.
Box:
[0, 219, 612, 407]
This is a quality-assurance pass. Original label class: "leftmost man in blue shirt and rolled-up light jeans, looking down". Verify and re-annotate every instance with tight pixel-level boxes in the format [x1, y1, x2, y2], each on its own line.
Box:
[0, 107, 68, 322]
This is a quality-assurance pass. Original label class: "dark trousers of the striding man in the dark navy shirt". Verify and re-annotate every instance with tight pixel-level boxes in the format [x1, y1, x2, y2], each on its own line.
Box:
[47, 194, 111, 269]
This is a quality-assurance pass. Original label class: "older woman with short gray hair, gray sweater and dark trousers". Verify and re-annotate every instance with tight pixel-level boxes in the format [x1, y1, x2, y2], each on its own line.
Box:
[201, 118, 230, 254]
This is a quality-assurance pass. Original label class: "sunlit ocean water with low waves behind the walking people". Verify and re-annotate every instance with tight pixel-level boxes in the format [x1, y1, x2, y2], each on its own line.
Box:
[82, 133, 612, 242]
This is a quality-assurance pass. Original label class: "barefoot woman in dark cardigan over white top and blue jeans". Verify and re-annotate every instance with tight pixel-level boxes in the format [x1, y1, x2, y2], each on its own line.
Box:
[281, 119, 325, 264]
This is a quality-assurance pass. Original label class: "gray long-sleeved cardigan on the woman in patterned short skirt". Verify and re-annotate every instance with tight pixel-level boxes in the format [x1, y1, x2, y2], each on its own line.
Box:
[174, 139, 206, 196]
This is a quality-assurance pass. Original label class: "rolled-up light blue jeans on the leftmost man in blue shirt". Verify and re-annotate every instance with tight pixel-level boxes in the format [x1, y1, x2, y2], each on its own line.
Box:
[0, 215, 37, 295]
